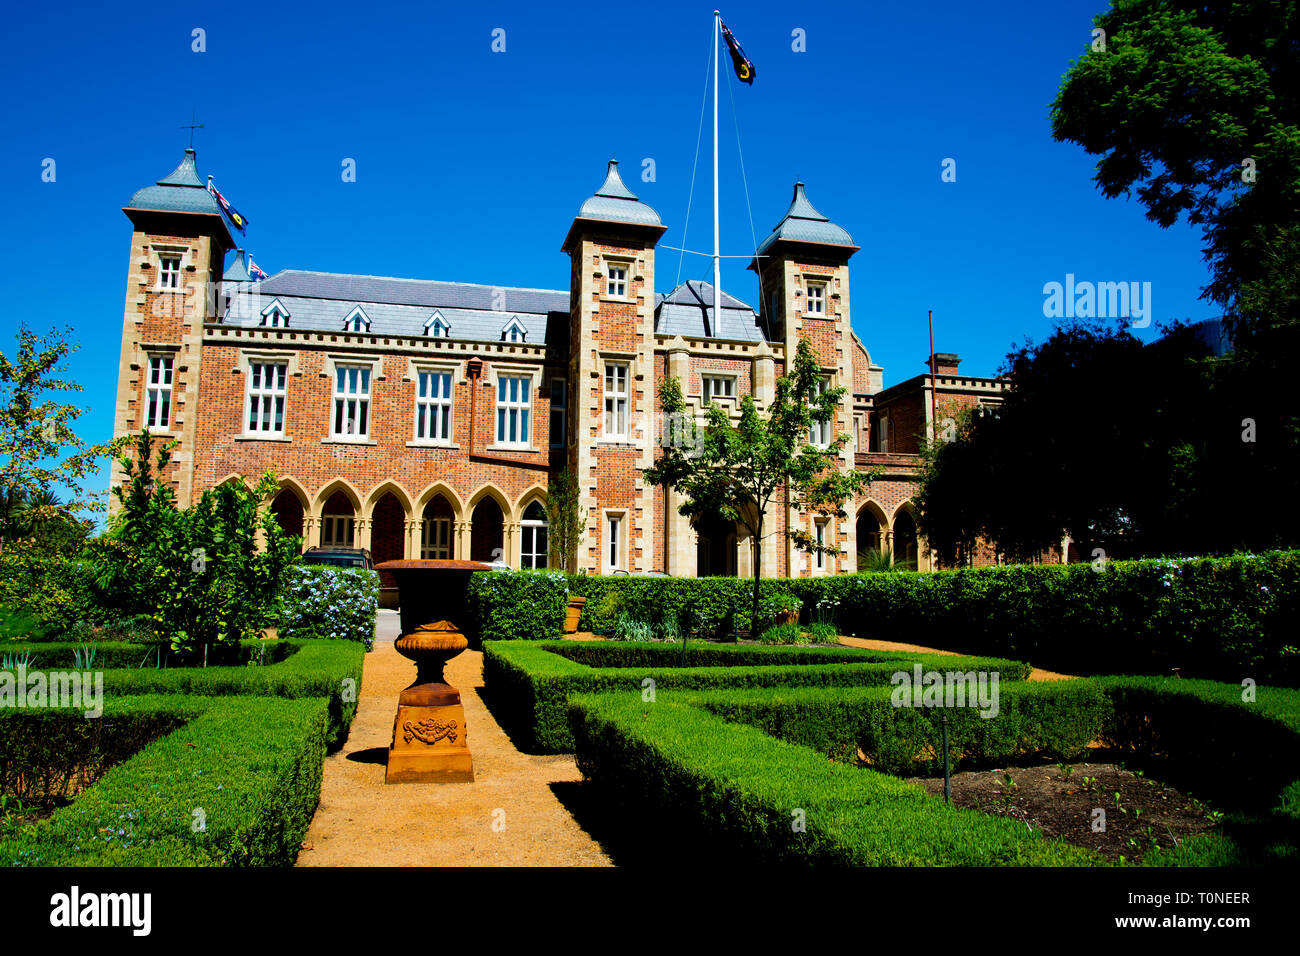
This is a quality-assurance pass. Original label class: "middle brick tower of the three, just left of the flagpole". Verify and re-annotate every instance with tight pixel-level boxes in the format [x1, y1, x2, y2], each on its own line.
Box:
[563, 160, 666, 574]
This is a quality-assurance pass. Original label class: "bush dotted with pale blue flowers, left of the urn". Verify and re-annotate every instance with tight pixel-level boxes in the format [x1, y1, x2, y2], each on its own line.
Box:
[280, 564, 380, 650]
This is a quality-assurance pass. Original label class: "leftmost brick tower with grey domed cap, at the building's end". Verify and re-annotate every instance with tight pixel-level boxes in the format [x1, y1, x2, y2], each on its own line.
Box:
[111, 150, 235, 507]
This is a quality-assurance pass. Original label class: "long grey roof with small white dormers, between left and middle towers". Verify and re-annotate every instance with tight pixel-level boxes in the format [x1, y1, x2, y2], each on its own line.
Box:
[222, 271, 569, 345]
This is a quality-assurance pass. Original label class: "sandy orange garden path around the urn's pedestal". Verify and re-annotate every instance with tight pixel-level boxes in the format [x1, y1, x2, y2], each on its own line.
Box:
[298, 617, 610, 866]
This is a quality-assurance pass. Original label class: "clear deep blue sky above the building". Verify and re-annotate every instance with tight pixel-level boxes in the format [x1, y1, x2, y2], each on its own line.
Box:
[0, 0, 1216, 494]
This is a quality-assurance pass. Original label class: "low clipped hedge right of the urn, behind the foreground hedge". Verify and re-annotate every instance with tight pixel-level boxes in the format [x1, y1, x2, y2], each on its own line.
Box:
[484, 641, 1030, 753]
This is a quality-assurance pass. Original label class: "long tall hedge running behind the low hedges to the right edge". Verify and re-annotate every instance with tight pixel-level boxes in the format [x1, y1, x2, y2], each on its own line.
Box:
[471, 551, 1300, 687]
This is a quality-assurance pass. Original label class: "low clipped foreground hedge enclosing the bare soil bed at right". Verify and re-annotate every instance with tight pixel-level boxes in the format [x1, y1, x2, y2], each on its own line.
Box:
[568, 676, 1300, 866]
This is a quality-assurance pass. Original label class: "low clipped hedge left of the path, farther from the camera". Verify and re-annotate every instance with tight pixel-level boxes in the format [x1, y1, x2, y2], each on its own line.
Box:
[5, 640, 365, 748]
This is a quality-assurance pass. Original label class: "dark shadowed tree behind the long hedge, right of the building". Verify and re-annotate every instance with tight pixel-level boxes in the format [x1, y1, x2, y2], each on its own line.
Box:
[915, 323, 1222, 564]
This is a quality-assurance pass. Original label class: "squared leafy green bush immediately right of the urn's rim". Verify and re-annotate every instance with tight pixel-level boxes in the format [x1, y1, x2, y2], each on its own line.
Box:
[465, 570, 569, 641]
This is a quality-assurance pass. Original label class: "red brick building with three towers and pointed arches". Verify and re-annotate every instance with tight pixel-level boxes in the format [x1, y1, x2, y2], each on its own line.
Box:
[113, 150, 1019, 575]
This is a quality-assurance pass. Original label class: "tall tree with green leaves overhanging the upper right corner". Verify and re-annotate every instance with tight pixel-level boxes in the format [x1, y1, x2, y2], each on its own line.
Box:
[1052, 0, 1300, 332]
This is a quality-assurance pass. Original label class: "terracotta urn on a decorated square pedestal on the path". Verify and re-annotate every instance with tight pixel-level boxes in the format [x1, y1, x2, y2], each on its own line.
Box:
[376, 561, 491, 783]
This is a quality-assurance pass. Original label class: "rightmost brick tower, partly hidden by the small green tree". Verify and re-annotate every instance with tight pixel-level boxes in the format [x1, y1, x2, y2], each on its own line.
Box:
[750, 182, 858, 578]
